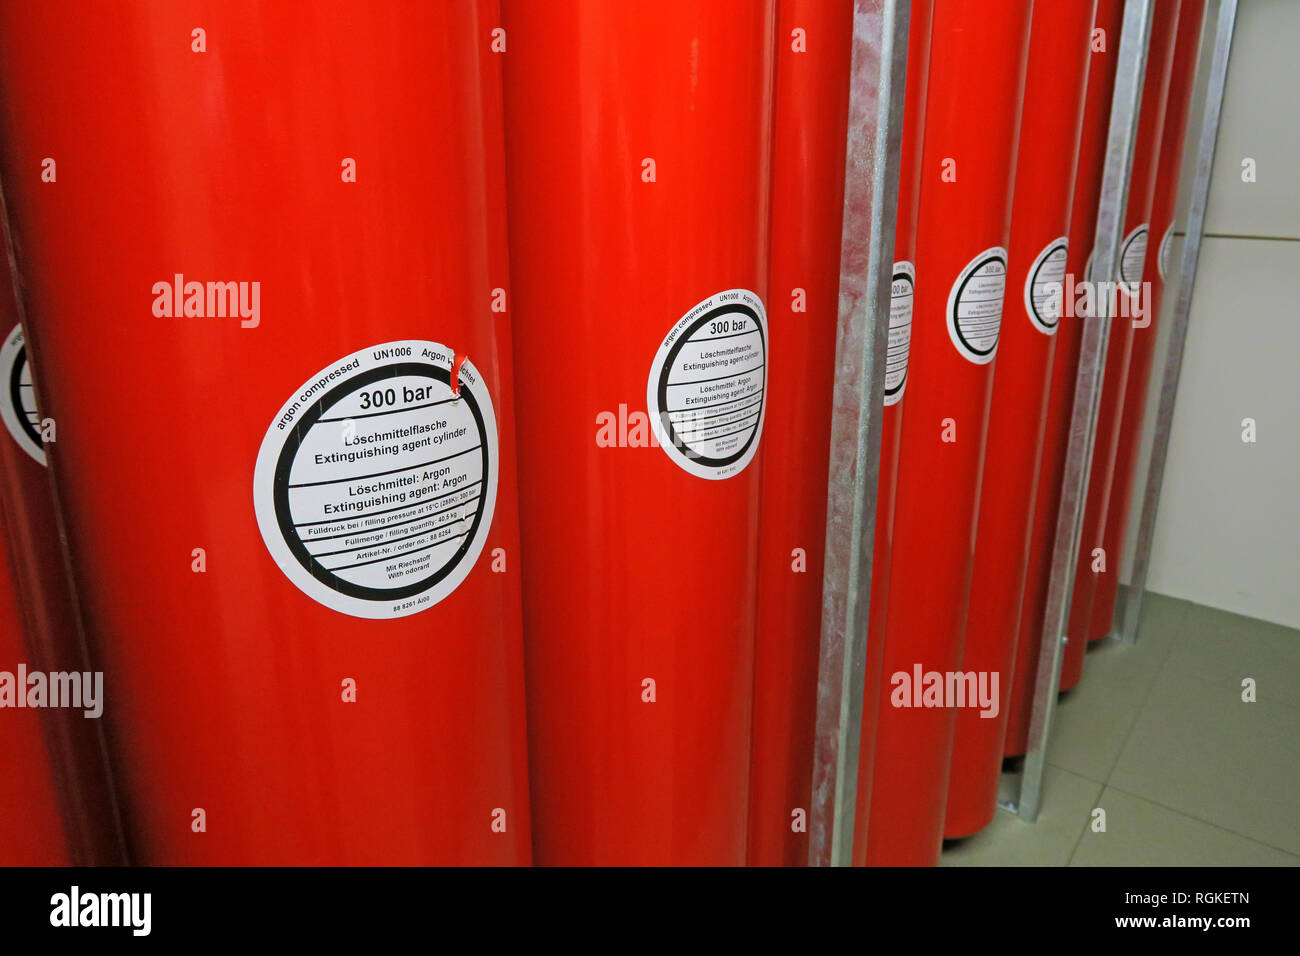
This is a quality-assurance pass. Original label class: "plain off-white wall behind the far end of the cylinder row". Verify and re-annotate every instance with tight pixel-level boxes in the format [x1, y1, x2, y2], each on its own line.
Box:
[1128, 0, 1300, 627]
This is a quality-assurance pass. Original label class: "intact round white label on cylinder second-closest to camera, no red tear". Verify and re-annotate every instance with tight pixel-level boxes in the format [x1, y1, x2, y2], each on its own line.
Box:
[646, 289, 767, 479]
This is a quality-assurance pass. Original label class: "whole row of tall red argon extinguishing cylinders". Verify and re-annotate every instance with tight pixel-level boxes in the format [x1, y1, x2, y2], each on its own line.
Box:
[0, 0, 1201, 864]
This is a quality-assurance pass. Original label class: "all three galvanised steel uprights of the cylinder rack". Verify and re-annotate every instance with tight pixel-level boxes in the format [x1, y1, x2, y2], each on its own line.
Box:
[809, 0, 1238, 842]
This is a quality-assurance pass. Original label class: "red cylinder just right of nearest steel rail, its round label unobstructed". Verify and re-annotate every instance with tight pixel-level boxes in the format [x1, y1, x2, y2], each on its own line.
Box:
[867, 0, 1032, 865]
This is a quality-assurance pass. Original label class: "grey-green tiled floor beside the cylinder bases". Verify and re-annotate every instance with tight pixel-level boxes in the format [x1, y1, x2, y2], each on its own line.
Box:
[943, 594, 1300, 866]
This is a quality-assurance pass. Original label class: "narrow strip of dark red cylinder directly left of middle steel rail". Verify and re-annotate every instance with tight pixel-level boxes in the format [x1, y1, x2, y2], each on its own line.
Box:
[1004, 0, 1125, 757]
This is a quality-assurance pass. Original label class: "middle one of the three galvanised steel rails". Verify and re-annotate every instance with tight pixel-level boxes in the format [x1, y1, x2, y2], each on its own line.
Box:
[1015, 0, 1154, 823]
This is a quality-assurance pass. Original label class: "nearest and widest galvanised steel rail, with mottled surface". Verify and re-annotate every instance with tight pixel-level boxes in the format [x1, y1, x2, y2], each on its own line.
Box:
[809, 0, 911, 866]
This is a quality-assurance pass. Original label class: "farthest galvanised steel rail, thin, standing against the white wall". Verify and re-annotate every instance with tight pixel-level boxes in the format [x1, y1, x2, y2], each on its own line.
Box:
[1113, 0, 1238, 644]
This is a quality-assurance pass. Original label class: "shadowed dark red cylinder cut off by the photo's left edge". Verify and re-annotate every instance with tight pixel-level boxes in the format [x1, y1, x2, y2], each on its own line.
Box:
[0, 217, 125, 865]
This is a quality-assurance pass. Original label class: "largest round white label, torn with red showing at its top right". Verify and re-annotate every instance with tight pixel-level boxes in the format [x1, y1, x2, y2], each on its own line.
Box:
[254, 341, 499, 618]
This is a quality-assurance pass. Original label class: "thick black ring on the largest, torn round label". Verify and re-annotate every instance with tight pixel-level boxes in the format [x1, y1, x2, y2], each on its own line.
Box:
[272, 362, 490, 601]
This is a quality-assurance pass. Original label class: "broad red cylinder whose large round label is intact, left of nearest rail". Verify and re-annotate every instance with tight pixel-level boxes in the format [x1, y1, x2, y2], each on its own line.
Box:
[503, 0, 774, 864]
